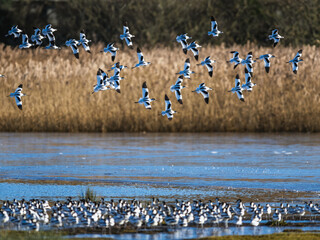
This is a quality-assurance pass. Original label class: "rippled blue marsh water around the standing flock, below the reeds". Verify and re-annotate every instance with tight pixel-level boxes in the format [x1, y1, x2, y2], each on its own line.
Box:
[0, 133, 320, 239]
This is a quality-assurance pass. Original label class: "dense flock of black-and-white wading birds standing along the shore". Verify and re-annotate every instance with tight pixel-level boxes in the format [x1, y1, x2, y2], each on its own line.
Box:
[0, 198, 320, 230]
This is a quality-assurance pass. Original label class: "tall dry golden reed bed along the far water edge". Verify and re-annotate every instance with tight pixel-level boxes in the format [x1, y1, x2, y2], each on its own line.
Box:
[0, 44, 320, 132]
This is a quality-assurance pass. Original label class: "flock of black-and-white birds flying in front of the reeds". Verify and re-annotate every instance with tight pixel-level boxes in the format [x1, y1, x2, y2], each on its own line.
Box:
[0, 17, 303, 120]
